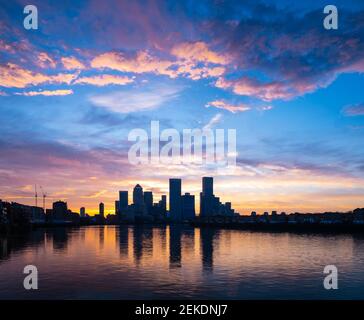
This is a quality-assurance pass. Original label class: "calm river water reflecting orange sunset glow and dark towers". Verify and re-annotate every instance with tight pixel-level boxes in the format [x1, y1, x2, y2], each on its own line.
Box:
[0, 226, 364, 299]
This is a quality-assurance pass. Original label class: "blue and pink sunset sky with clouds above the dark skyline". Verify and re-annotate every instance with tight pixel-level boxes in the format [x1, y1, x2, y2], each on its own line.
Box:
[0, 0, 364, 214]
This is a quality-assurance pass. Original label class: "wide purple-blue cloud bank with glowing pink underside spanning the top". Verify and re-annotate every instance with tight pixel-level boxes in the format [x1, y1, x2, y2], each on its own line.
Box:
[0, 1, 364, 101]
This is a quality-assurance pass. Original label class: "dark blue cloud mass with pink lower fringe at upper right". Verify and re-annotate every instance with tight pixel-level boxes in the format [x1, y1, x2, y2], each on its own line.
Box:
[207, 2, 364, 101]
